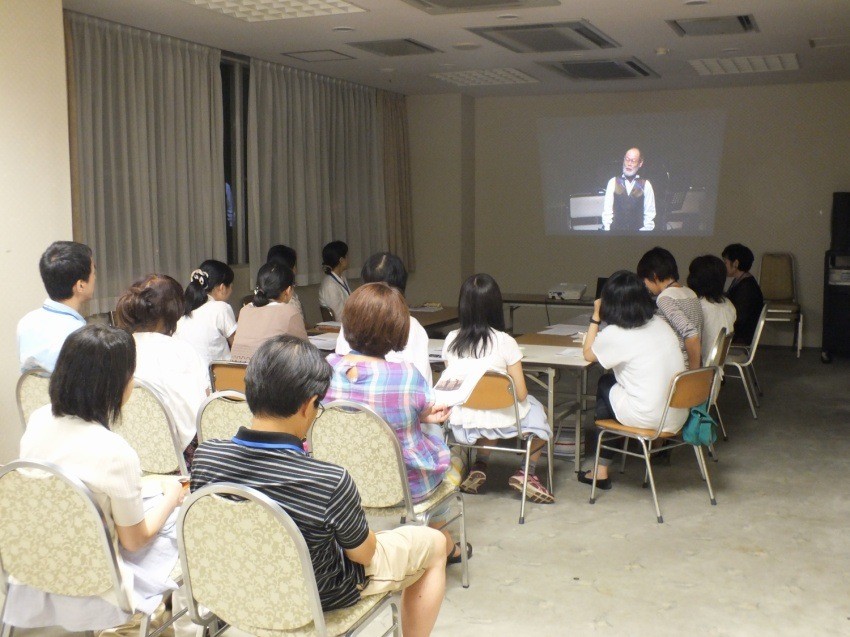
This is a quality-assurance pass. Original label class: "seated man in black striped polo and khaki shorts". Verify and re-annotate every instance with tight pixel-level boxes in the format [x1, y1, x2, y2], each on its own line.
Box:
[191, 335, 446, 636]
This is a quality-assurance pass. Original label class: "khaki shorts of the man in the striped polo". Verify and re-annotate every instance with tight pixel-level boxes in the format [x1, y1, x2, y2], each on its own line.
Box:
[360, 526, 445, 597]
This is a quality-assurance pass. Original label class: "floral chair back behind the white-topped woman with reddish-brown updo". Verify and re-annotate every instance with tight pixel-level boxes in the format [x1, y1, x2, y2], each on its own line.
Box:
[112, 378, 189, 476]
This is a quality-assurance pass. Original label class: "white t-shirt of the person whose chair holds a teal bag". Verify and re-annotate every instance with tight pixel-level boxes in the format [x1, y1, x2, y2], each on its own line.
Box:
[591, 316, 688, 432]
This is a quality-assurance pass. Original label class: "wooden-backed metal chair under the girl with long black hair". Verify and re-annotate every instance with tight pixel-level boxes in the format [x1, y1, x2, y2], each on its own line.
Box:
[447, 371, 555, 524]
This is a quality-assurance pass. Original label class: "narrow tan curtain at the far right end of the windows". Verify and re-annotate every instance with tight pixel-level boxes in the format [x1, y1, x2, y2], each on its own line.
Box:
[378, 91, 416, 272]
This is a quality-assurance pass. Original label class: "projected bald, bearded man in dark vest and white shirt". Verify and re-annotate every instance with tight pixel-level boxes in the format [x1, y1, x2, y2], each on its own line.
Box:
[602, 148, 655, 233]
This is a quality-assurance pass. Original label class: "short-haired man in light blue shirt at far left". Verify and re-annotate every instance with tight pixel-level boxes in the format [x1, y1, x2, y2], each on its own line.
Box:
[18, 241, 96, 372]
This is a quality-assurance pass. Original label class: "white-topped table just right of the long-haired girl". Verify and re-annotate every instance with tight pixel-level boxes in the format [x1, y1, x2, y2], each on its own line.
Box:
[428, 334, 594, 471]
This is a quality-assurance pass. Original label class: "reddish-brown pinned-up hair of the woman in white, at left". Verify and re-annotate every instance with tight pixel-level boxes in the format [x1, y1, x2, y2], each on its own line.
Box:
[115, 274, 183, 336]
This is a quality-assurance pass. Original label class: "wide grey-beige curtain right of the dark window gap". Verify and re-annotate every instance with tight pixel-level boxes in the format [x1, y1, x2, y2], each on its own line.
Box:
[247, 60, 387, 285]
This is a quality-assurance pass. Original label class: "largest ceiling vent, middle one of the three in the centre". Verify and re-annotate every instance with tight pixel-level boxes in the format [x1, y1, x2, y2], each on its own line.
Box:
[469, 20, 620, 53]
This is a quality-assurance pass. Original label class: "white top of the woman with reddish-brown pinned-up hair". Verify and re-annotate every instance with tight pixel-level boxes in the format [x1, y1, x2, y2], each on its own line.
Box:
[133, 332, 210, 449]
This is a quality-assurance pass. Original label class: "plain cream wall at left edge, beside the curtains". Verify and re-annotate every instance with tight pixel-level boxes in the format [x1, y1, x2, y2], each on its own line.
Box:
[0, 0, 71, 462]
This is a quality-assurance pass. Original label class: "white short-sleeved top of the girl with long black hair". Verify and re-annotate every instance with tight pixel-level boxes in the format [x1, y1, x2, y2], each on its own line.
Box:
[443, 329, 530, 429]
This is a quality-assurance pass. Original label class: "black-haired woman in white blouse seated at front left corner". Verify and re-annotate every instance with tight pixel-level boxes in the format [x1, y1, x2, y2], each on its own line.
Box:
[10, 324, 184, 632]
